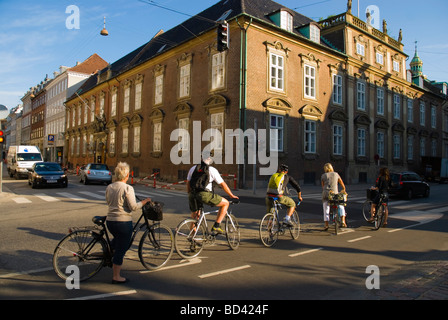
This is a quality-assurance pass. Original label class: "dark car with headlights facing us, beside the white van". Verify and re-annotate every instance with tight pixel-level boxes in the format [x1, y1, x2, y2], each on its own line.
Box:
[28, 162, 68, 188]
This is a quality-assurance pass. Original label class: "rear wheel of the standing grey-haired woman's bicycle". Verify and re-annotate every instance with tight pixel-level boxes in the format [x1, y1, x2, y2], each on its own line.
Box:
[53, 230, 108, 281]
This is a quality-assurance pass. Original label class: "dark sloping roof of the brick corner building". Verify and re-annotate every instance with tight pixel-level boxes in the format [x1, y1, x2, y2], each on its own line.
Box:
[68, 0, 324, 101]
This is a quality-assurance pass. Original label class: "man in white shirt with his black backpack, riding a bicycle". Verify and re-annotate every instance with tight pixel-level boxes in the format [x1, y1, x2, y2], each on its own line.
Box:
[187, 154, 239, 233]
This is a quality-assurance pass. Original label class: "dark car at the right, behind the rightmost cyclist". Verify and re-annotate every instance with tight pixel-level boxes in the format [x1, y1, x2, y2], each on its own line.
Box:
[389, 171, 430, 200]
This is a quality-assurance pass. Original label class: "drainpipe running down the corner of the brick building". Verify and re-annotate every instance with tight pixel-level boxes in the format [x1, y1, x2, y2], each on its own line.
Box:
[236, 18, 252, 188]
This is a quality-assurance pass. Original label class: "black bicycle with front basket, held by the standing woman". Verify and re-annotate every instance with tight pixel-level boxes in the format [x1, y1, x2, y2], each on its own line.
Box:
[53, 197, 174, 281]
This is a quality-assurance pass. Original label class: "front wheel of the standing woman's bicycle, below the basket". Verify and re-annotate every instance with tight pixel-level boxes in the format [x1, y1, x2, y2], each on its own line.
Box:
[138, 223, 174, 270]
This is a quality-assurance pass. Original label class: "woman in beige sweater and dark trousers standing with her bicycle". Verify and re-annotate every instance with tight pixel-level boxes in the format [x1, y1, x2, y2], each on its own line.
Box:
[106, 162, 151, 284]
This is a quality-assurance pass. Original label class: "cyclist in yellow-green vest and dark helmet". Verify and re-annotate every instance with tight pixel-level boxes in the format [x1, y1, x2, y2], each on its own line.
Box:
[266, 164, 303, 226]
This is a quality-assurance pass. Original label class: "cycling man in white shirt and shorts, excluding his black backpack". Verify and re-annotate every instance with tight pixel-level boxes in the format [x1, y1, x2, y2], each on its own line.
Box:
[187, 156, 239, 233]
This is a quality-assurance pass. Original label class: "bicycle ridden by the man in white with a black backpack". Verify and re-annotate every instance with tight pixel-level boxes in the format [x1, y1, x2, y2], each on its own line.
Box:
[174, 199, 240, 259]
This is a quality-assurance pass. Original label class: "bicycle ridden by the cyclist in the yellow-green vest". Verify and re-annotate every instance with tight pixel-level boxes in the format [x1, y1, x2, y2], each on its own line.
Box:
[259, 197, 300, 247]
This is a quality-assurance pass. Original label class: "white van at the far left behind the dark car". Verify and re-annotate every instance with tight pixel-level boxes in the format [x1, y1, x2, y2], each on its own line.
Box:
[6, 146, 43, 179]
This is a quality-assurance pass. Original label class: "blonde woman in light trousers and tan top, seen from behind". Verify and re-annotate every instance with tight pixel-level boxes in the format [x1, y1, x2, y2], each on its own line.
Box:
[321, 163, 347, 230]
